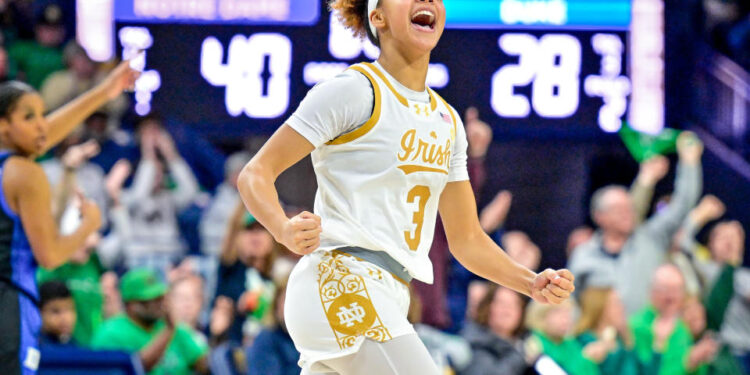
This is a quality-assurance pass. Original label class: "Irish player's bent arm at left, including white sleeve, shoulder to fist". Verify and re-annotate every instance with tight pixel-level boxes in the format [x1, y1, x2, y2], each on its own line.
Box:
[237, 71, 374, 255]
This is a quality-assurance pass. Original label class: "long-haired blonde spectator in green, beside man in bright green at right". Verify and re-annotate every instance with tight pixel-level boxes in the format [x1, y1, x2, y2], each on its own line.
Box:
[576, 288, 639, 375]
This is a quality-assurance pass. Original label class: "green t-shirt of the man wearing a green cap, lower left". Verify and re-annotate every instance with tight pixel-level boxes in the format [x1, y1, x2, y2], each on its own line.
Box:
[91, 314, 208, 375]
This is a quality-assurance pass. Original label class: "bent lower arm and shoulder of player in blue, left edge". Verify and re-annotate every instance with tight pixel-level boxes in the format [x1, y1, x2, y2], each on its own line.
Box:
[2, 157, 101, 268]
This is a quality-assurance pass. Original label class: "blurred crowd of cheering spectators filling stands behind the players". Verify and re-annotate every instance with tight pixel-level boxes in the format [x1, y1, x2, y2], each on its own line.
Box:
[0, 0, 750, 375]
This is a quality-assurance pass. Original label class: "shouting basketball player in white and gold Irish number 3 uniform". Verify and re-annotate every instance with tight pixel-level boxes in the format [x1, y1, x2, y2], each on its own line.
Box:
[238, 0, 573, 375]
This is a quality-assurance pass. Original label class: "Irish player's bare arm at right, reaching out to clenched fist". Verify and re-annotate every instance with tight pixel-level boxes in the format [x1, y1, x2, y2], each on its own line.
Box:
[439, 181, 575, 304]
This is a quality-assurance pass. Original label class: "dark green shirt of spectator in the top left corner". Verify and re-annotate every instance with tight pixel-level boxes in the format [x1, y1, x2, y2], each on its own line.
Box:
[8, 40, 65, 90]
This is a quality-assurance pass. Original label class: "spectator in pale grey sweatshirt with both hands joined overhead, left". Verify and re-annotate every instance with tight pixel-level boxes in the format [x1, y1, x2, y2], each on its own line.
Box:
[112, 117, 199, 269]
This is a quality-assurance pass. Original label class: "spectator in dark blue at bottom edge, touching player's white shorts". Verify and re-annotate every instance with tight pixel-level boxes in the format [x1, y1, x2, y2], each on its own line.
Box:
[247, 284, 300, 375]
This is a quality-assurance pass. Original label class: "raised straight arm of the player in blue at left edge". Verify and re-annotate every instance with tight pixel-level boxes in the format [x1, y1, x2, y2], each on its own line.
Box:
[44, 61, 140, 152]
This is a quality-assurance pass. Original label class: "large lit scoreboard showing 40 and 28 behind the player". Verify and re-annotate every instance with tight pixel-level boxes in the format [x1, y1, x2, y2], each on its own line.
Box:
[78, 0, 658, 139]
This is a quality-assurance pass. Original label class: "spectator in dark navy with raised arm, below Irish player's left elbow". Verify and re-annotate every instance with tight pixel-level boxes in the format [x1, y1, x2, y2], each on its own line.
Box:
[212, 203, 280, 343]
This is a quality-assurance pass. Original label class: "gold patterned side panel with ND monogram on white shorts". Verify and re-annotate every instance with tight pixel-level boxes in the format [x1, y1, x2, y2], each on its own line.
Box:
[318, 251, 391, 349]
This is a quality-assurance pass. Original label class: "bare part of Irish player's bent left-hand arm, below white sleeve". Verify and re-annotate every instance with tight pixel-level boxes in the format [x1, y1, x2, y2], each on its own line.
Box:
[237, 124, 321, 255]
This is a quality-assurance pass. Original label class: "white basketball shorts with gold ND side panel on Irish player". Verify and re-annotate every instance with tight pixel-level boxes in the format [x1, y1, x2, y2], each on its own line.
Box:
[284, 250, 415, 373]
